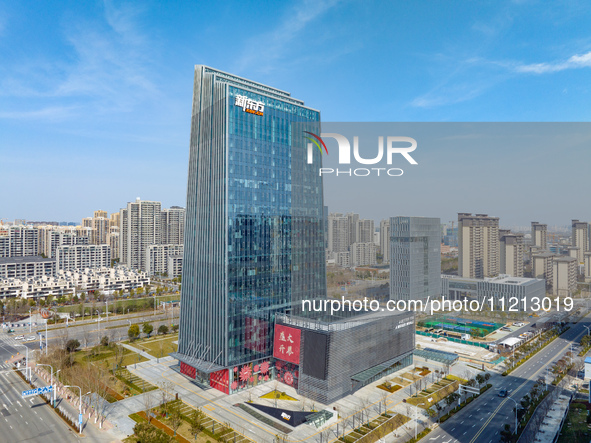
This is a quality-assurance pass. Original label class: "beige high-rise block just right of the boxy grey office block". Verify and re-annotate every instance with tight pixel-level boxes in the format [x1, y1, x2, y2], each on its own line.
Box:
[458, 213, 500, 278]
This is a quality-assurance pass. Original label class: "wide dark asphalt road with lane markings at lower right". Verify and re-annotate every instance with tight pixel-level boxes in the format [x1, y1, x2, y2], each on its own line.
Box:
[421, 317, 590, 443]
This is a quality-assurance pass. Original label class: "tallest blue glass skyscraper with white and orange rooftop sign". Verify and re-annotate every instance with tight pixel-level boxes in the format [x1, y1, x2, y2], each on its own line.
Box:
[174, 66, 326, 392]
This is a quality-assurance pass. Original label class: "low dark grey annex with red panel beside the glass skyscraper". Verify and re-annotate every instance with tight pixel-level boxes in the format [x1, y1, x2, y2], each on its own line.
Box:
[275, 312, 415, 404]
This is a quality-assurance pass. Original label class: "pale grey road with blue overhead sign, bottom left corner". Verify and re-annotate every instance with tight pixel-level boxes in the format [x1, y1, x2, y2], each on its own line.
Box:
[0, 371, 79, 442]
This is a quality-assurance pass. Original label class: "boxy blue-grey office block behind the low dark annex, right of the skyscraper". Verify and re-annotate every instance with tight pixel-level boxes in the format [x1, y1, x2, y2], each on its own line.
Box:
[390, 217, 441, 301]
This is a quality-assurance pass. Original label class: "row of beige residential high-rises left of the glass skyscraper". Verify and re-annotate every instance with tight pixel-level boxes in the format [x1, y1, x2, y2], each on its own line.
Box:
[0, 198, 185, 277]
